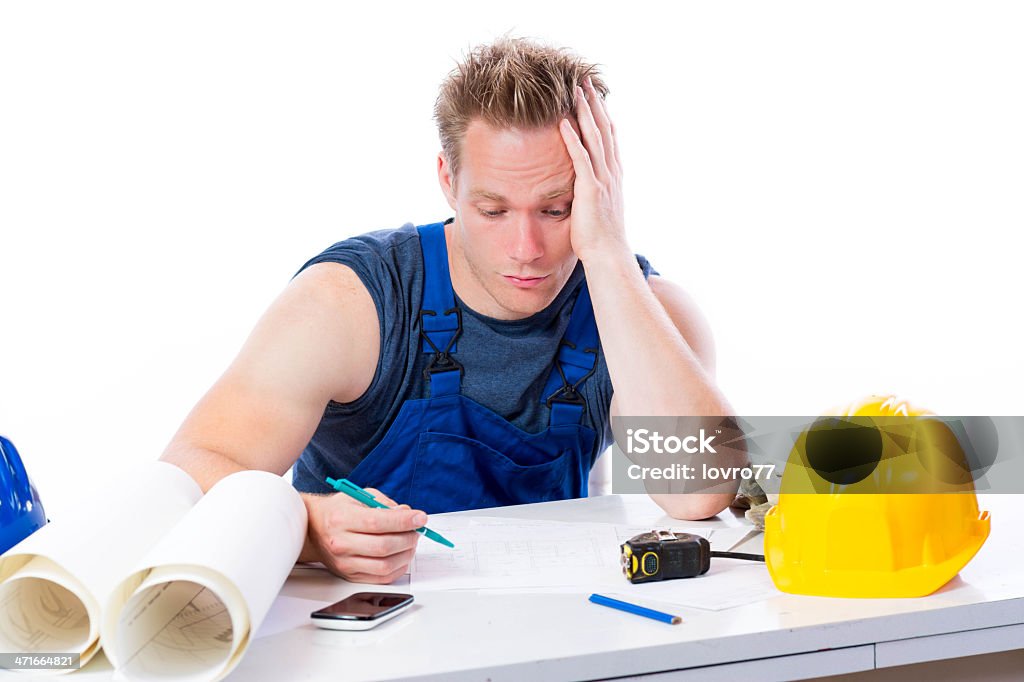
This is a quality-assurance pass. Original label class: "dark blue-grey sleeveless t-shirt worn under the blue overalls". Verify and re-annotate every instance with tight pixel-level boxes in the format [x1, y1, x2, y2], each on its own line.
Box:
[293, 223, 657, 491]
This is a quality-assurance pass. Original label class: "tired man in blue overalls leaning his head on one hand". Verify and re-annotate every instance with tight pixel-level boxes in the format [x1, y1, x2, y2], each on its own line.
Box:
[163, 39, 731, 583]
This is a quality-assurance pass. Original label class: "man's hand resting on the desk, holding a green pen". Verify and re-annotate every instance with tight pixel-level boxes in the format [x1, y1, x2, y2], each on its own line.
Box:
[302, 487, 427, 585]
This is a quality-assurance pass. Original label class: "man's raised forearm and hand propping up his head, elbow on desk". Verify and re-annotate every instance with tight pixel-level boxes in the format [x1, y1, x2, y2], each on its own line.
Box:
[558, 78, 736, 518]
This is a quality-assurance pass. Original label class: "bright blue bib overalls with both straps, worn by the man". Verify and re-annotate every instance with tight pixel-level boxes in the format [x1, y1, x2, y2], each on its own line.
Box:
[348, 223, 599, 514]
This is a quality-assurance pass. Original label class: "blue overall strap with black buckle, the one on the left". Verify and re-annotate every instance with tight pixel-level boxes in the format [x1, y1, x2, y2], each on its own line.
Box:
[416, 222, 463, 397]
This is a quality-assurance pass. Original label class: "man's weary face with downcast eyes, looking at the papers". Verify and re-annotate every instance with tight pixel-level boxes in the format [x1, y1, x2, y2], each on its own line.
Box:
[437, 121, 577, 319]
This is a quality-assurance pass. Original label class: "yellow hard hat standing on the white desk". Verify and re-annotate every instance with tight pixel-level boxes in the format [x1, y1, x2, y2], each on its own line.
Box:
[765, 395, 990, 597]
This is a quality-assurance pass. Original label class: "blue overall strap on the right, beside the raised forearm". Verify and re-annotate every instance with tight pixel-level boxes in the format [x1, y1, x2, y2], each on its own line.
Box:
[542, 281, 600, 419]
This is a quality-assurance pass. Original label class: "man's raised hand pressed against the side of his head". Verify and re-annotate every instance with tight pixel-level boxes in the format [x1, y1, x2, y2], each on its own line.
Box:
[558, 78, 632, 266]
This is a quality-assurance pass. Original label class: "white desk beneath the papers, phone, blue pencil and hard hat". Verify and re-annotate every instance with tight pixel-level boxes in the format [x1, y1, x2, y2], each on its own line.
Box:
[75, 496, 1024, 682]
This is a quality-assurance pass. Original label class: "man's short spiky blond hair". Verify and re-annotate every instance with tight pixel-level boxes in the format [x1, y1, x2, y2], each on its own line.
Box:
[434, 36, 608, 180]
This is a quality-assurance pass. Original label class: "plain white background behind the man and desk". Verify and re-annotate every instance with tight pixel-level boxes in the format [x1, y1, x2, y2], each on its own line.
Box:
[0, 0, 1024, 518]
